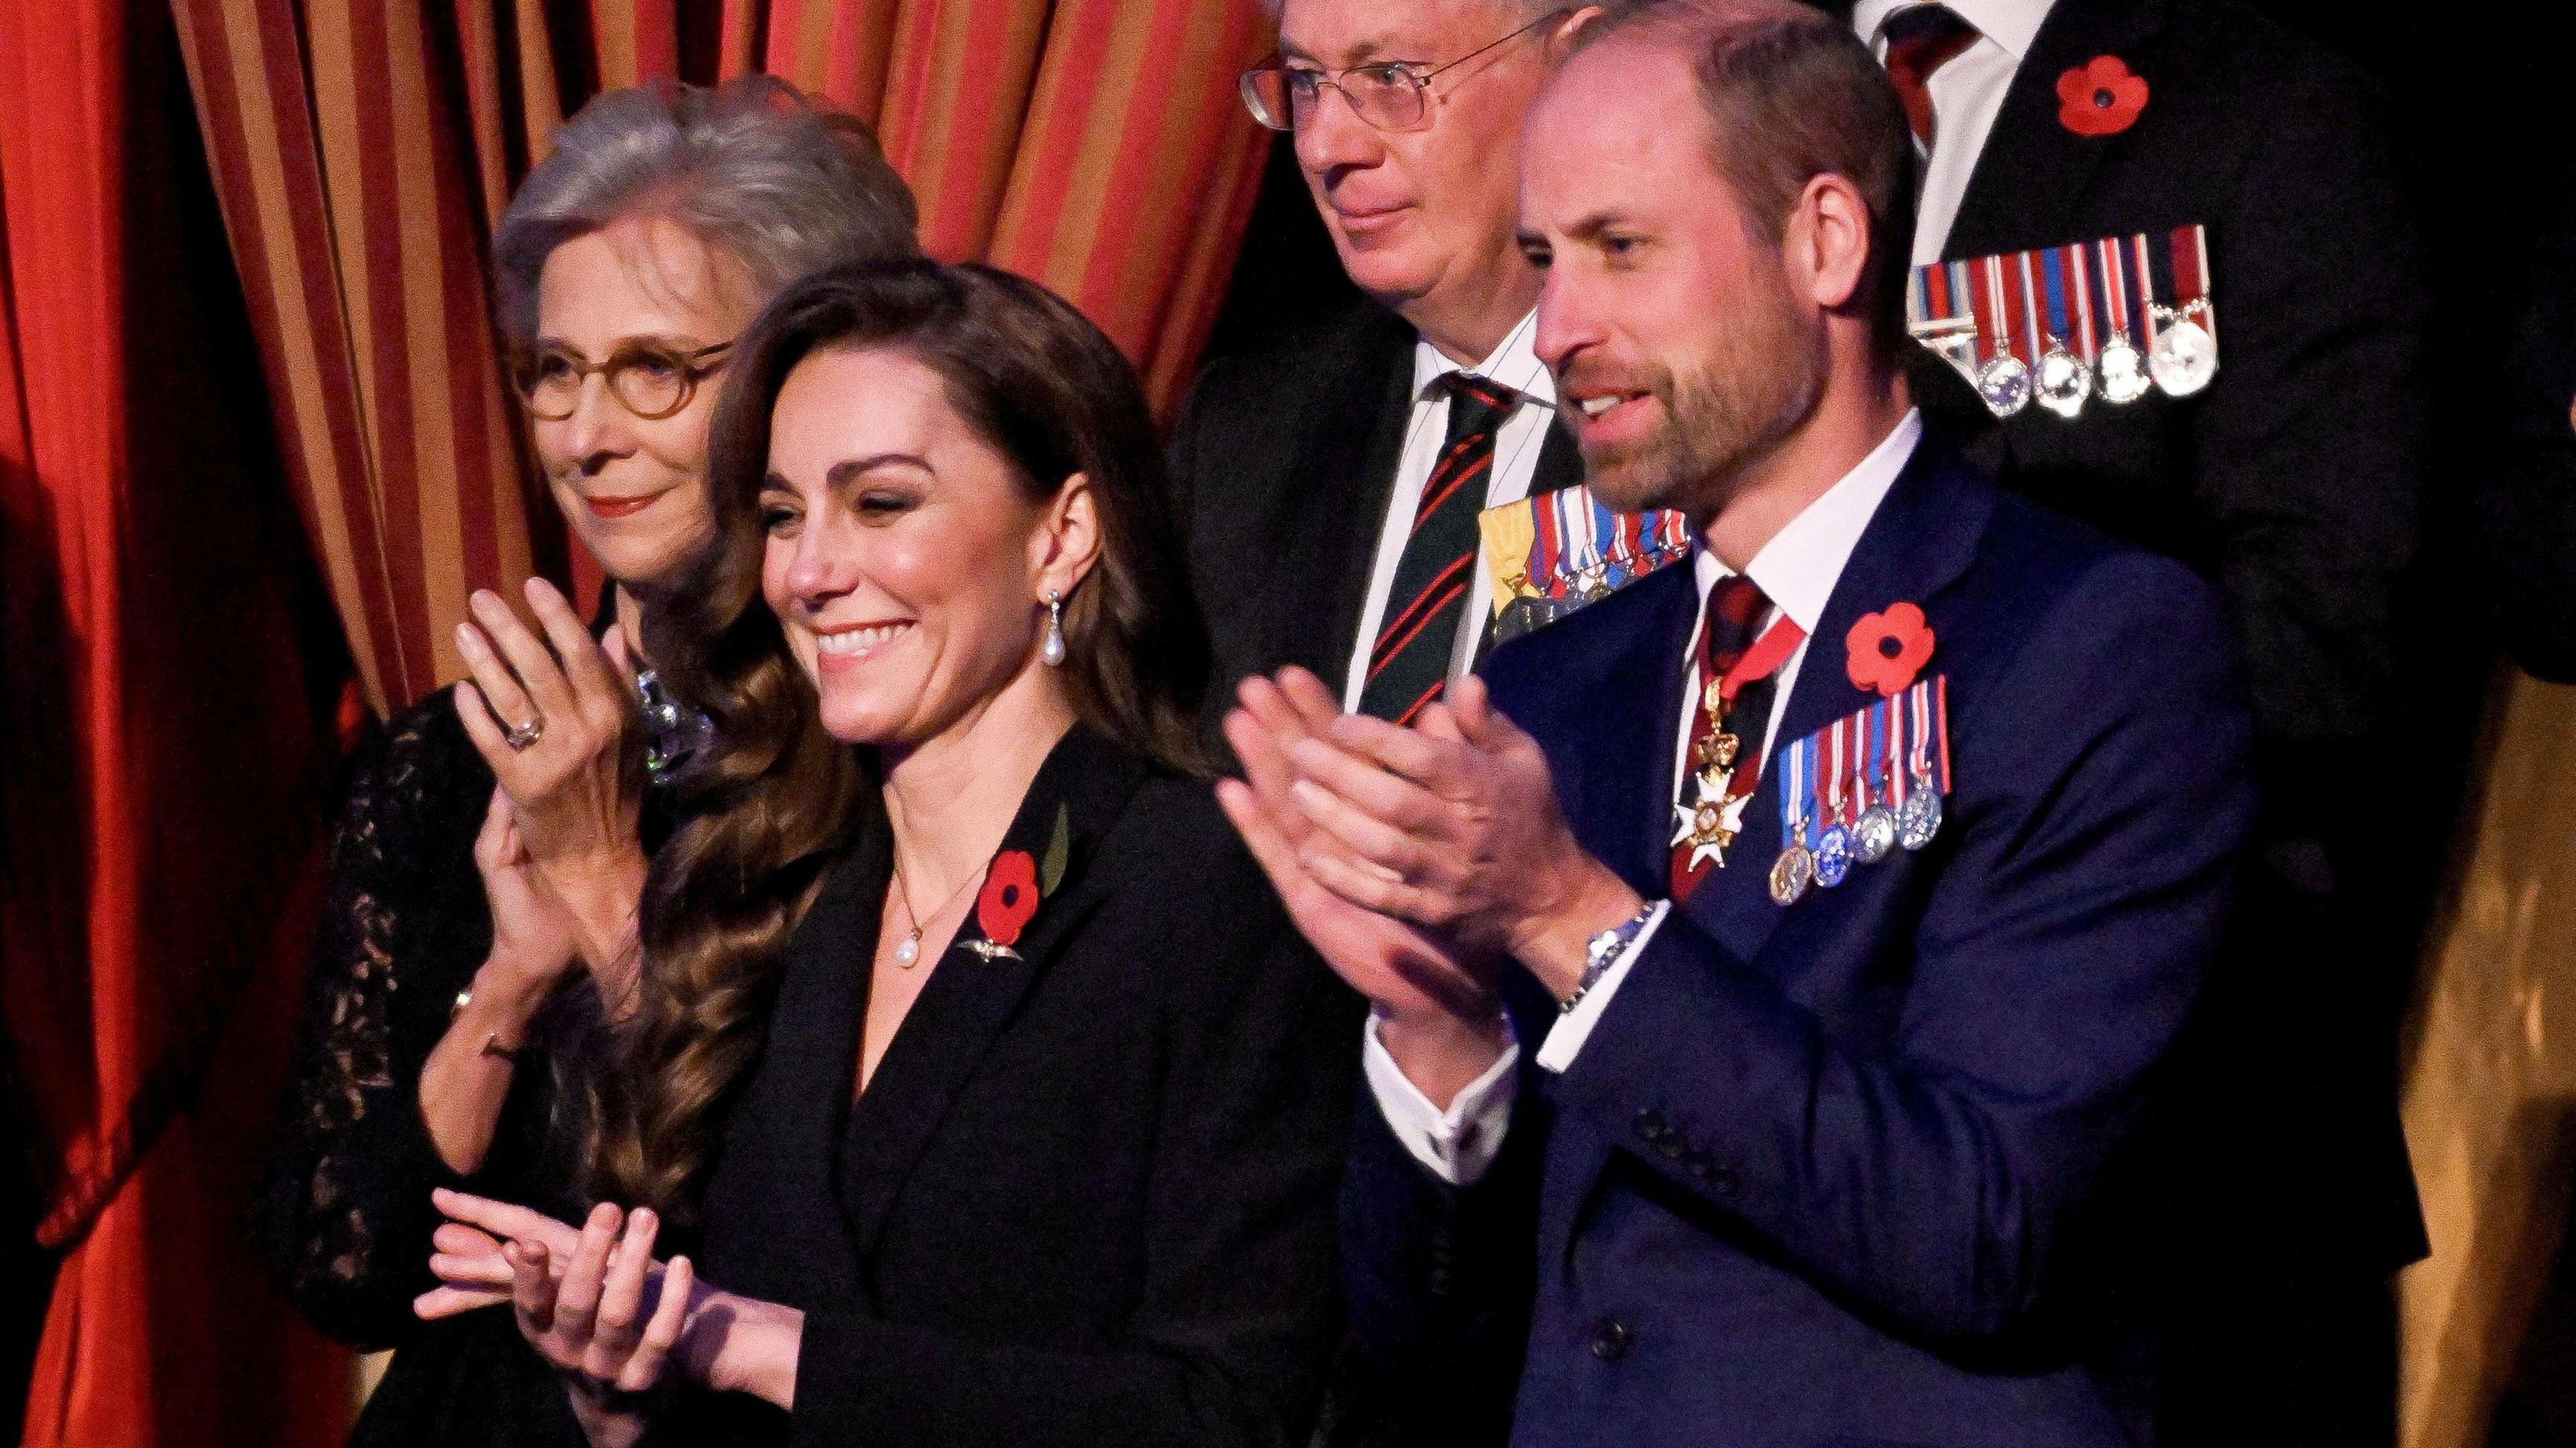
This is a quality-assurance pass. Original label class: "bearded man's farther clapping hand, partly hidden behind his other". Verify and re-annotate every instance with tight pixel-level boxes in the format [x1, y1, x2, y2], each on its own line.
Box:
[1216, 670, 1512, 1105]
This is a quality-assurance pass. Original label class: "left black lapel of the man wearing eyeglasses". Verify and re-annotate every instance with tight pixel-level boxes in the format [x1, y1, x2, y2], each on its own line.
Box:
[1267, 312, 1414, 693]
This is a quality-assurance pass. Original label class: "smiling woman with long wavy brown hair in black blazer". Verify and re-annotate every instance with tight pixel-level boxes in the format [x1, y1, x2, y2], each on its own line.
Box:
[423, 263, 1360, 1448]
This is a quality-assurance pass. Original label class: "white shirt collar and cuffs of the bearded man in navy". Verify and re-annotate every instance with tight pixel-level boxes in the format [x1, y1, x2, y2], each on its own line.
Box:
[1360, 412, 1924, 1185]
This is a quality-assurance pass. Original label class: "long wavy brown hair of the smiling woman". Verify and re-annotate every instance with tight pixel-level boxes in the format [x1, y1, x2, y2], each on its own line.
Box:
[590, 260, 1211, 1224]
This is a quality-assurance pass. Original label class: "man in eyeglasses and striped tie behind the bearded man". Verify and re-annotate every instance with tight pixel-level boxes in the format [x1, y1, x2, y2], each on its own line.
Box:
[1172, 0, 1597, 724]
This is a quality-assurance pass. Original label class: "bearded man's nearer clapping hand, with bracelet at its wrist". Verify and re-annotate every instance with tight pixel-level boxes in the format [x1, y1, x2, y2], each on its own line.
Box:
[1277, 675, 1644, 997]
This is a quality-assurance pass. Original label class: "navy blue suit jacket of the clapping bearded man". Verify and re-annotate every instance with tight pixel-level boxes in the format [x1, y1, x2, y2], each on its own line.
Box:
[1344, 441, 2254, 1448]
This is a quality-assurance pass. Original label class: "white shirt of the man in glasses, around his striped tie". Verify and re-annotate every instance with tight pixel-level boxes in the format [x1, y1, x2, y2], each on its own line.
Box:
[1342, 312, 1556, 711]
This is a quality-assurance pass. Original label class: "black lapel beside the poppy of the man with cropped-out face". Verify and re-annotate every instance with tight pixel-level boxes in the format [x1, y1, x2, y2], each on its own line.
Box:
[1942, 0, 2164, 260]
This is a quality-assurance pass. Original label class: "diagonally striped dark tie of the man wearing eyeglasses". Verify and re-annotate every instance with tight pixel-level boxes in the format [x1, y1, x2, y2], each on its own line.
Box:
[1360, 371, 1520, 724]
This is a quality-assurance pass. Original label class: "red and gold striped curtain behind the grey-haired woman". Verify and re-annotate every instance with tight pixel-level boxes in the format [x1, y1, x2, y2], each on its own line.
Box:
[170, 0, 1270, 714]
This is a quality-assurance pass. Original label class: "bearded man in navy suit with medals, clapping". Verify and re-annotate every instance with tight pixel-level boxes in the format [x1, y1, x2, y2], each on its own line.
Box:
[1221, 0, 2254, 1448]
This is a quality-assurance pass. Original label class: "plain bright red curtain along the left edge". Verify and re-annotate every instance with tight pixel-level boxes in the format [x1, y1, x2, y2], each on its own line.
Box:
[0, 0, 345, 1445]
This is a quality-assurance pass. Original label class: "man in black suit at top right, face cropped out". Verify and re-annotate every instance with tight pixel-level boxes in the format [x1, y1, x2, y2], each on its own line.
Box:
[1831, 0, 2450, 1443]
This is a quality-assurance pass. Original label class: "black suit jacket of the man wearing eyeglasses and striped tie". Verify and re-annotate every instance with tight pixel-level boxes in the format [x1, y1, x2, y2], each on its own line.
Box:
[1172, 299, 1585, 724]
